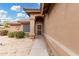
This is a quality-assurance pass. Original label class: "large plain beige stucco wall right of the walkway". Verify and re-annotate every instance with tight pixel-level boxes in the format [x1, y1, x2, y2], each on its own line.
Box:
[44, 4, 79, 55]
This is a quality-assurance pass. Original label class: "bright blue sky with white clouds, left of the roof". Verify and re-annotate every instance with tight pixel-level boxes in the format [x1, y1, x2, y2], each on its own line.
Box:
[0, 3, 40, 22]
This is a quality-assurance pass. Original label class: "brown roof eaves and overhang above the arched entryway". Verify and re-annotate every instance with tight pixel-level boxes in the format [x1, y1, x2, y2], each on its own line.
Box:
[23, 3, 55, 16]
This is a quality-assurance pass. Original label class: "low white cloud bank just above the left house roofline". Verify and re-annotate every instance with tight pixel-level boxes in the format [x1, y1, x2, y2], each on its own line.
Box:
[0, 10, 29, 23]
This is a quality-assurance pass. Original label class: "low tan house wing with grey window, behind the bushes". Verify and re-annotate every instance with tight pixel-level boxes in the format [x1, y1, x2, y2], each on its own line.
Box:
[9, 20, 30, 32]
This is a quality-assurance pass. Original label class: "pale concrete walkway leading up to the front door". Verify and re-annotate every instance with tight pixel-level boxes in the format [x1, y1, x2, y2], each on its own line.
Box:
[30, 37, 48, 56]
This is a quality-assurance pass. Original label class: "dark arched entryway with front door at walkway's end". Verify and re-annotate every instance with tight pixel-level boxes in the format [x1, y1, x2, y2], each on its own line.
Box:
[35, 16, 44, 36]
